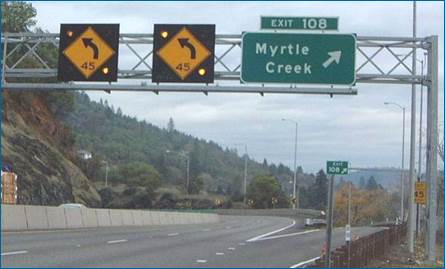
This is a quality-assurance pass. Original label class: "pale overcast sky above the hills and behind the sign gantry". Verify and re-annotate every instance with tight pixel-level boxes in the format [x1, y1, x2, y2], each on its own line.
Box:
[33, 1, 444, 172]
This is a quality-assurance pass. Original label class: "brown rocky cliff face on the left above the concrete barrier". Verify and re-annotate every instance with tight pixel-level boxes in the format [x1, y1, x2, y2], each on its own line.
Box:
[1, 92, 101, 207]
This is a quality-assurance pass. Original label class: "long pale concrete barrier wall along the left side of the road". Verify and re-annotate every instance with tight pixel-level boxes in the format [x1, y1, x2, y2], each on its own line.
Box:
[1, 205, 219, 231]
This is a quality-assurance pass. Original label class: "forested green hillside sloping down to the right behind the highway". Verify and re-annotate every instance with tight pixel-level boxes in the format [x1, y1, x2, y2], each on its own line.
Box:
[64, 93, 314, 206]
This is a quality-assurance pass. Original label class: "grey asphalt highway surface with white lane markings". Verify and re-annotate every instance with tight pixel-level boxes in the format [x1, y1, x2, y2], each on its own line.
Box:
[1, 216, 381, 268]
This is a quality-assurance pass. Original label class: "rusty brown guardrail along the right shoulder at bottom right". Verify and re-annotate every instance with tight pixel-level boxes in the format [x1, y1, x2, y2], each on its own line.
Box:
[306, 223, 407, 268]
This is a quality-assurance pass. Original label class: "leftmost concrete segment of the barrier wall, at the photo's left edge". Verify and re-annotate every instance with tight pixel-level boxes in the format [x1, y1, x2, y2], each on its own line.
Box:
[2, 205, 28, 231]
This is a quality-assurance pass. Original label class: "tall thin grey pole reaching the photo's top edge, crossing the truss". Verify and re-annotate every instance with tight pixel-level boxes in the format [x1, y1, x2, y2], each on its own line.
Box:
[408, 1, 417, 254]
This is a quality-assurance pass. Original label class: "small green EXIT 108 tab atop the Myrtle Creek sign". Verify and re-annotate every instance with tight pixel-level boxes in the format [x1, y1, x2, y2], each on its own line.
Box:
[261, 16, 338, 31]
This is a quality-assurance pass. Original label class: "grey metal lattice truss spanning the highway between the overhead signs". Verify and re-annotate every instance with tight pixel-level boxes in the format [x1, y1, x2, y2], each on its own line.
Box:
[2, 33, 429, 88]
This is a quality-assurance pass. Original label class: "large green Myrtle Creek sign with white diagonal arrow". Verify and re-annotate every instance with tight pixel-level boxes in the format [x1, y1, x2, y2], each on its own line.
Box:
[241, 32, 356, 85]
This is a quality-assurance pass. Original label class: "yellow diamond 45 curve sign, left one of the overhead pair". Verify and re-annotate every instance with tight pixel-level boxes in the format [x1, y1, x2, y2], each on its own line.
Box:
[63, 27, 116, 79]
